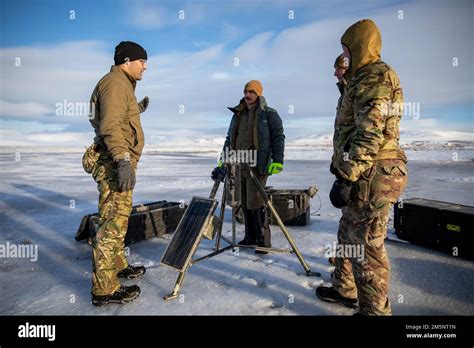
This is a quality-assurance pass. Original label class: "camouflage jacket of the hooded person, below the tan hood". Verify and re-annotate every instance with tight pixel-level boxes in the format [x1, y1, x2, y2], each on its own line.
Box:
[332, 61, 406, 181]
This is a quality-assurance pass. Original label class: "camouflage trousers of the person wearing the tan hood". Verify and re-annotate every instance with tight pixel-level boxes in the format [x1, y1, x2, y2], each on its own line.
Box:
[332, 160, 408, 315]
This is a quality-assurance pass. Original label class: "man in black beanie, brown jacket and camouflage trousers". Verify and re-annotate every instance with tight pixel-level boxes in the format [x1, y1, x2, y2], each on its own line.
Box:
[83, 41, 148, 306]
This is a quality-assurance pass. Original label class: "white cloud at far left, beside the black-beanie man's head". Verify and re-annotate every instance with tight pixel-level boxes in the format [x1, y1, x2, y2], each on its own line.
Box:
[0, 41, 113, 108]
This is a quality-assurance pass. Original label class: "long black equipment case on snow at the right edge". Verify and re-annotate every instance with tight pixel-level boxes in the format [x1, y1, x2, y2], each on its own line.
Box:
[394, 198, 474, 259]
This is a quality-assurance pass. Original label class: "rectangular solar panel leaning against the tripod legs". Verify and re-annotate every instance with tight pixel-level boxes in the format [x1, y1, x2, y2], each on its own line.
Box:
[161, 197, 218, 271]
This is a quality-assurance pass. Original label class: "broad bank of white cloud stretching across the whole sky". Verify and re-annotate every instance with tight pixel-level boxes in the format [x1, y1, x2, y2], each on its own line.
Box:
[0, 1, 474, 145]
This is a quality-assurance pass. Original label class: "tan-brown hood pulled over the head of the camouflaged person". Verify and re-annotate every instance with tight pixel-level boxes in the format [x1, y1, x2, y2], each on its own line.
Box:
[341, 19, 382, 79]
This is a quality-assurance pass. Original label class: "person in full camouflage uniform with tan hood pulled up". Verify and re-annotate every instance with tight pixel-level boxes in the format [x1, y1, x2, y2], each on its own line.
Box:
[316, 19, 408, 315]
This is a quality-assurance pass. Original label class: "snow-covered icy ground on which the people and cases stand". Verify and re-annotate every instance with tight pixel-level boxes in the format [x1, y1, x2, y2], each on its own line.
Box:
[0, 148, 474, 315]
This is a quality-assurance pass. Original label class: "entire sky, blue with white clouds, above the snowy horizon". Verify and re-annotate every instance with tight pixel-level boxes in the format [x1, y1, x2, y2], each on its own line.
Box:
[0, 0, 474, 145]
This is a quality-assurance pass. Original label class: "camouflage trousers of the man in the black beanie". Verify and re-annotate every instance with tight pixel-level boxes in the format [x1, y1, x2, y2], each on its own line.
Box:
[92, 156, 136, 295]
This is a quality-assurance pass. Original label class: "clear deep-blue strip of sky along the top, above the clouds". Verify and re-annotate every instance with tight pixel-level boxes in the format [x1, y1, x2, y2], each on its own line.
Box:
[1, 0, 406, 49]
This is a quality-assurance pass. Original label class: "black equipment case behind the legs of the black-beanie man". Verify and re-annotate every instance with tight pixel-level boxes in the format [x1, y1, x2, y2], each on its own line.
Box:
[75, 201, 187, 245]
